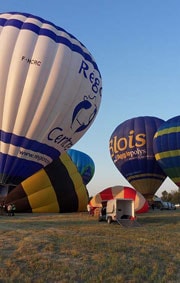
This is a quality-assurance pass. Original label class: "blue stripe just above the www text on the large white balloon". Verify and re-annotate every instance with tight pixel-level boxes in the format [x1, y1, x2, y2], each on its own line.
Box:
[0, 130, 60, 159]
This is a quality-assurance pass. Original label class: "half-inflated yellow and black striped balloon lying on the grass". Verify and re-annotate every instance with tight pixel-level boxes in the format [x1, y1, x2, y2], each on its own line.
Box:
[5, 152, 89, 213]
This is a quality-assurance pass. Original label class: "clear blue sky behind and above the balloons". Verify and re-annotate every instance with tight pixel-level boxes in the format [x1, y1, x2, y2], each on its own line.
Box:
[0, 0, 180, 195]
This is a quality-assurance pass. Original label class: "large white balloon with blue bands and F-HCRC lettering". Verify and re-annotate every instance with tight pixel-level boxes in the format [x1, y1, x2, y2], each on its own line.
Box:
[0, 12, 102, 185]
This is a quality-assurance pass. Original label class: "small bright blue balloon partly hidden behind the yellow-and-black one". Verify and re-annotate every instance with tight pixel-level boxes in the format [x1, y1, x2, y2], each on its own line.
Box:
[67, 149, 95, 185]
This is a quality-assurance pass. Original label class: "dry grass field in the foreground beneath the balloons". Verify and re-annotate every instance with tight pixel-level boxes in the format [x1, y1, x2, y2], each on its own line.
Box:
[0, 209, 180, 283]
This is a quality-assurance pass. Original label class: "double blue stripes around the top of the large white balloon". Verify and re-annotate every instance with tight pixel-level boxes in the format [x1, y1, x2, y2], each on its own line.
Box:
[0, 13, 101, 77]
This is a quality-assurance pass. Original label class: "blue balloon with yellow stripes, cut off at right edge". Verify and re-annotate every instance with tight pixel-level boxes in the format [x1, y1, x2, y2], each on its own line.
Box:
[153, 116, 180, 186]
